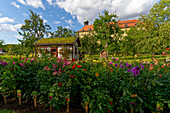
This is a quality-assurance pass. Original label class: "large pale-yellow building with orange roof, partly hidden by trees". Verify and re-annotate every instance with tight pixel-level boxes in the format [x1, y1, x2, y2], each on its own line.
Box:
[76, 19, 138, 38]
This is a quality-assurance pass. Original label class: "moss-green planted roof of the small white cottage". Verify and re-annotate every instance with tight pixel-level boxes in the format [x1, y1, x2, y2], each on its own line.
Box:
[34, 37, 80, 46]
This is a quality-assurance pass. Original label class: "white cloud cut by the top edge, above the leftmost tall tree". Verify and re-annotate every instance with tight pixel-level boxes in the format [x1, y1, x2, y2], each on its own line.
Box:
[18, 0, 45, 10]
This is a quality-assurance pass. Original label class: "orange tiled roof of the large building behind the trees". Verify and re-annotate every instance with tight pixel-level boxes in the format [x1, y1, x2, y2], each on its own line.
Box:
[77, 19, 138, 32]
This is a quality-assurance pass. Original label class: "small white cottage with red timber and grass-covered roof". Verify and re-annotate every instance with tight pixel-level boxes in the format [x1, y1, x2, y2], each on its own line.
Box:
[34, 37, 81, 60]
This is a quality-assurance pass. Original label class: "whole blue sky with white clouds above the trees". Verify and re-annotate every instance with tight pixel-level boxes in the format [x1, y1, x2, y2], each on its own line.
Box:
[0, 0, 160, 44]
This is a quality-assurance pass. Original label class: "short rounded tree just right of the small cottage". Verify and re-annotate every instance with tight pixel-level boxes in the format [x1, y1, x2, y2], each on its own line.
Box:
[80, 33, 99, 57]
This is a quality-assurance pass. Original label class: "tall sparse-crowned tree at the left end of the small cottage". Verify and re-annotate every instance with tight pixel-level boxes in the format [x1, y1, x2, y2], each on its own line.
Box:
[18, 10, 51, 57]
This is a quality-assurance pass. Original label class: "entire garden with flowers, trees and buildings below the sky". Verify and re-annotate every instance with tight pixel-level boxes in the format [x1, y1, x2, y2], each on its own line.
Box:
[0, 0, 170, 113]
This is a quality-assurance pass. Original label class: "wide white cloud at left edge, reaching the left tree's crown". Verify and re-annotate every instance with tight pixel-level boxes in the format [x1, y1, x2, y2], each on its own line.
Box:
[0, 24, 22, 32]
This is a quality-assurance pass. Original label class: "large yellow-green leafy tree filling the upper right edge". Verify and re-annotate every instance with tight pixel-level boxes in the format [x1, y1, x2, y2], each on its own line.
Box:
[138, 0, 170, 59]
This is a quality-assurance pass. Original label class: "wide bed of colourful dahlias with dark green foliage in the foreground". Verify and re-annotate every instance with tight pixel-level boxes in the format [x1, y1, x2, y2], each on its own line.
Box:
[0, 55, 170, 113]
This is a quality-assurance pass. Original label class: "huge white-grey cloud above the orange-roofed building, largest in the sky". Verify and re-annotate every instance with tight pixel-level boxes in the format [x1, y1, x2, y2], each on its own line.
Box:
[56, 0, 159, 24]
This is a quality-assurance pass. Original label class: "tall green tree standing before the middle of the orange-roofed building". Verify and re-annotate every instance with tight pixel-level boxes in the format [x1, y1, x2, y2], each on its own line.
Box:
[93, 11, 122, 56]
